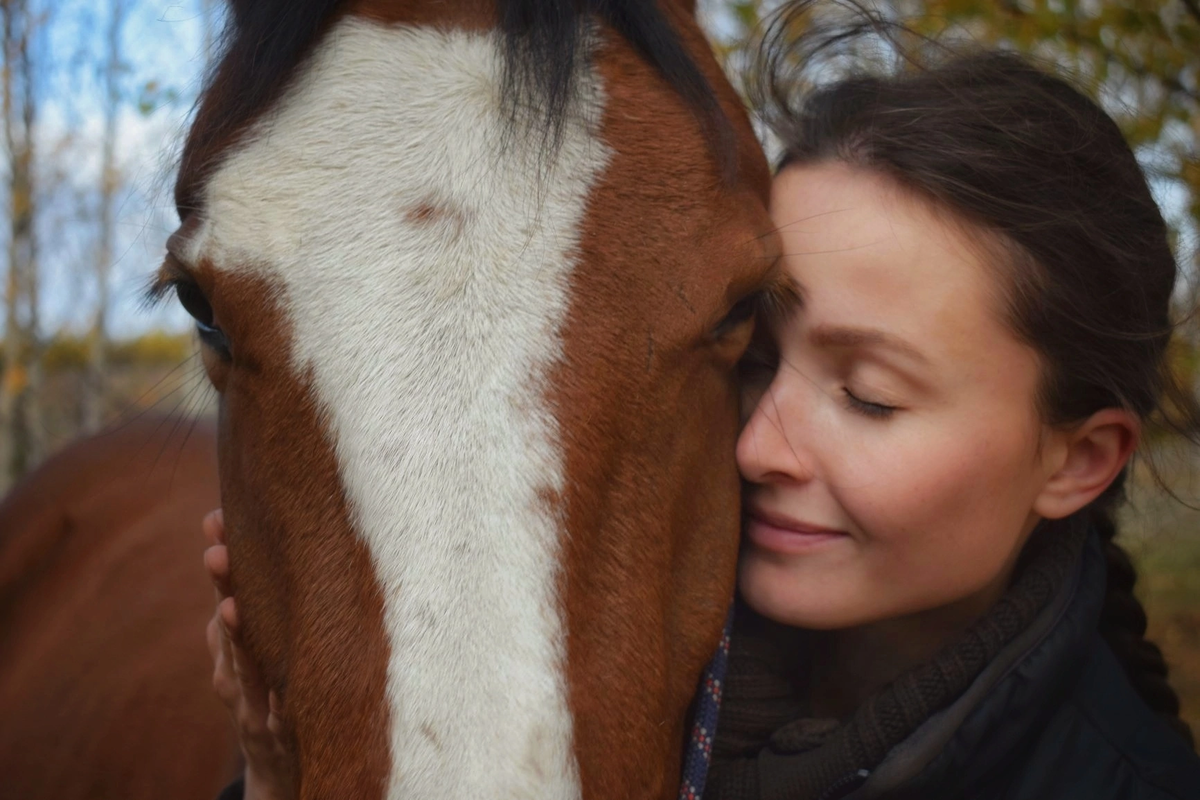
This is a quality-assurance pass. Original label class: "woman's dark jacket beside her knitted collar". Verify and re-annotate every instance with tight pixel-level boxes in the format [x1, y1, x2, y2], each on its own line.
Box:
[718, 535, 1200, 800]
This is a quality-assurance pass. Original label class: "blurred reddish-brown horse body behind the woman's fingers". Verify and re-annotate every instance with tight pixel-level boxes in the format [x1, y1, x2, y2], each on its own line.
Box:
[0, 419, 238, 800]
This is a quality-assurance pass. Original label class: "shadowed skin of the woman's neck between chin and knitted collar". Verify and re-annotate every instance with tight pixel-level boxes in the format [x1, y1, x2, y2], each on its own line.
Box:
[808, 571, 1012, 718]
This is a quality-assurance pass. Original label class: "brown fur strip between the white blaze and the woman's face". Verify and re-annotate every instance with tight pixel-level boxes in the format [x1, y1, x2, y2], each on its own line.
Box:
[551, 3, 774, 798]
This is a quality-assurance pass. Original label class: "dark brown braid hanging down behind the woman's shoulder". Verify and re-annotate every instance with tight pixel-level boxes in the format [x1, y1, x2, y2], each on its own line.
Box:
[1092, 509, 1195, 747]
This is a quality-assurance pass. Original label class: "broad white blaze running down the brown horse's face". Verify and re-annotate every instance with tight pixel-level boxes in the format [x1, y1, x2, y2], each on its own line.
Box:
[193, 18, 608, 799]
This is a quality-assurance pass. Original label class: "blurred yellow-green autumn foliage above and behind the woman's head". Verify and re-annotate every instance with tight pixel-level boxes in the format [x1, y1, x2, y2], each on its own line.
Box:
[702, 0, 1200, 237]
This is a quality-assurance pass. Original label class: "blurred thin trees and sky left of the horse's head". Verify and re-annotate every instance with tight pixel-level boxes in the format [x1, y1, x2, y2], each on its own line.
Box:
[0, 0, 224, 482]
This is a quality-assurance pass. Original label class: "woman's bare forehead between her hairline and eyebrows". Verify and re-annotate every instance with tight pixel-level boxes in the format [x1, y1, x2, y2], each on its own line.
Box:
[772, 163, 1015, 367]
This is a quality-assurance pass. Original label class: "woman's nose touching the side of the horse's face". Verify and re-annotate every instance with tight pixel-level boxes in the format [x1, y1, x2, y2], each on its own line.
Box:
[737, 381, 812, 483]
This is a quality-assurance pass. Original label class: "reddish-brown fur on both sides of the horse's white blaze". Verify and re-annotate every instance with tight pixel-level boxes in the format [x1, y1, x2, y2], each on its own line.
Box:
[10, 0, 776, 800]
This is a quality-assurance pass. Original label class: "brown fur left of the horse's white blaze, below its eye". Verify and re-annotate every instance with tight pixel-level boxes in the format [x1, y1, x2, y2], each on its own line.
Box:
[197, 267, 389, 798]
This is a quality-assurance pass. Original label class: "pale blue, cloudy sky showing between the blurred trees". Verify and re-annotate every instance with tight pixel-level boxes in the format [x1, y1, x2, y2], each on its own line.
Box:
[11, 0, 1196, 337]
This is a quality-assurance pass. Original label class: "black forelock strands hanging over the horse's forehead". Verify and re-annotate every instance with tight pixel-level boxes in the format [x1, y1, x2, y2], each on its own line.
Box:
[175, 0, 733, 218]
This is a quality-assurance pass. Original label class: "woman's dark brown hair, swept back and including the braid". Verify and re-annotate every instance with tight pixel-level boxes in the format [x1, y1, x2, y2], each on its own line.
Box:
[748, 0, 1200, 742]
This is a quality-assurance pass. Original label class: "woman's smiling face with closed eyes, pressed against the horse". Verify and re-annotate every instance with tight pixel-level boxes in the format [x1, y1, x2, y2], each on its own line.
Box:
[737, 163, 1049, 628]
